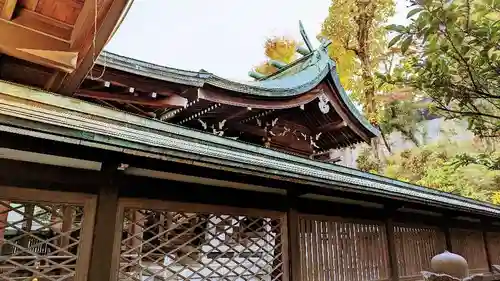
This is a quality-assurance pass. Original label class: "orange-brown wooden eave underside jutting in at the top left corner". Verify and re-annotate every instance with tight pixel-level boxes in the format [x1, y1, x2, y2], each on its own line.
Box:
[0, 0, 131, 95]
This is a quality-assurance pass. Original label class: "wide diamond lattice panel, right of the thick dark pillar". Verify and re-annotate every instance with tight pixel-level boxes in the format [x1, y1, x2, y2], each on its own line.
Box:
[119, 209, 283, 281]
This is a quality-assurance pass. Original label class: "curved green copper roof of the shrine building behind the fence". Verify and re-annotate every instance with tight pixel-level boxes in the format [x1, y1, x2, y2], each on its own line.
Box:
[97, 44, 380, 136]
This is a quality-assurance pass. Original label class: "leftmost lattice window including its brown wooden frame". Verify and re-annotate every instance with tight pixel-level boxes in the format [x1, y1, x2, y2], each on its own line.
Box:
[0, 187, 95, 281]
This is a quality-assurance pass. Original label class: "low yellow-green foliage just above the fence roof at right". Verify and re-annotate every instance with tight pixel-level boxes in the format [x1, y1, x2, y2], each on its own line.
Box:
[357, 138, 500, 204]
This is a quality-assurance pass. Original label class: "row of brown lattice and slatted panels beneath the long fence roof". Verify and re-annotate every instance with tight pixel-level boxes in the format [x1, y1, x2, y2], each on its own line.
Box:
[0, 184, 500, 281]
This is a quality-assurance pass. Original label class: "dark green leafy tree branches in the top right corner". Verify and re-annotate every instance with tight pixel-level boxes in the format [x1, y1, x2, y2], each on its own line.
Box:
[387, 0, 500, 137]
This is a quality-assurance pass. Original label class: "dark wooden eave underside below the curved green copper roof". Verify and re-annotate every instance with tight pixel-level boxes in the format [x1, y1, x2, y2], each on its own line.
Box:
[77, 63, 374, 155]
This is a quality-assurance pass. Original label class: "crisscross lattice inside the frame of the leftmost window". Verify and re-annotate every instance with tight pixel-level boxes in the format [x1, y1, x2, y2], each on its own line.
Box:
[0, 201, 83, 281]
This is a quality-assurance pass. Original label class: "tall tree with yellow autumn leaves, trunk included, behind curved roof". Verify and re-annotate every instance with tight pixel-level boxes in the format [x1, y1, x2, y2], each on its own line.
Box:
[322, 0, 394, 119]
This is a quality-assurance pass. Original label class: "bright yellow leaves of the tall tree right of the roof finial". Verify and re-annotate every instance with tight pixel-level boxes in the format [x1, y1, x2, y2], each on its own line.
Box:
[321, 0, 395, 103]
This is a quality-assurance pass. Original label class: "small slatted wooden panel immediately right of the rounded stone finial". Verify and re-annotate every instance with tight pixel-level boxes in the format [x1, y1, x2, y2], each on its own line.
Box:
[450, 229, 490, 273]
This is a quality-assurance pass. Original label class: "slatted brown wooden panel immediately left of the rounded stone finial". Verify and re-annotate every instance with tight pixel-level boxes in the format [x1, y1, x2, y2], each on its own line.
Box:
[394, 223, 446, 280]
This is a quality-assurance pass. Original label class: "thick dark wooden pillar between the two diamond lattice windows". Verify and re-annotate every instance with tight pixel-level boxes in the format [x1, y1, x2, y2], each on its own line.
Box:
[88, 182, 123, 281]
